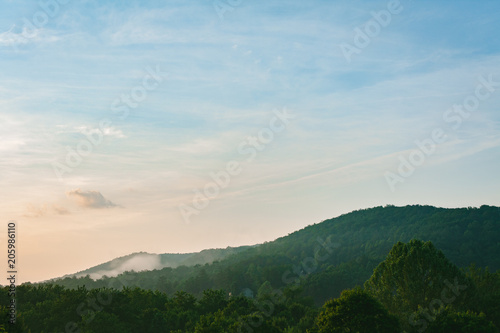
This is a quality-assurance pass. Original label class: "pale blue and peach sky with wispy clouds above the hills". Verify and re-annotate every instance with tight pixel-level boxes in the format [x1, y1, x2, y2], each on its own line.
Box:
[0, 0, 500, 282]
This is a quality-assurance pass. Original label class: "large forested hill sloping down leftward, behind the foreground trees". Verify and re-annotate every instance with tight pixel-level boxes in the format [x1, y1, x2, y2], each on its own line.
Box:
[47, 205, 500, 304]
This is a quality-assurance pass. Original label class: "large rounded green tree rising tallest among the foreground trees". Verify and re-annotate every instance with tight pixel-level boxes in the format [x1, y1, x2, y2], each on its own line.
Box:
[365, 240, 473, 314]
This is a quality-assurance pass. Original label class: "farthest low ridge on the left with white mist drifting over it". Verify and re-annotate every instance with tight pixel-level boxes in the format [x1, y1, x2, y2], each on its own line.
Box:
[63, 246, 251, 280]
